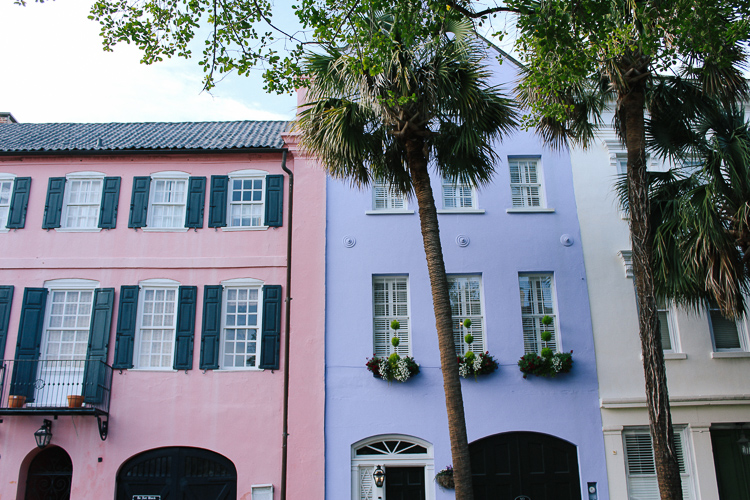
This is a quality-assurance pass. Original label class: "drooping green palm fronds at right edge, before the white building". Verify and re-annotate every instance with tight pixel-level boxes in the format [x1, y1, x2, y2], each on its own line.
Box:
[649, 102, 750, 318]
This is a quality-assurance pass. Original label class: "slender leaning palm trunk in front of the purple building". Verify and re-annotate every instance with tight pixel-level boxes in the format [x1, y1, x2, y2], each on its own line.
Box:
[405, 138, 474, 500]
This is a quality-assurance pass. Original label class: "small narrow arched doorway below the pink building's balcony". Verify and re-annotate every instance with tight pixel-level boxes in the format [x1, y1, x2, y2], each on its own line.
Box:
[24, 446, 73, 500]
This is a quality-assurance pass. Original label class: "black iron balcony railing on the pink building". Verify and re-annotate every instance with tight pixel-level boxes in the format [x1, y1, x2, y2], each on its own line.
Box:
[0, 359, 112, 414]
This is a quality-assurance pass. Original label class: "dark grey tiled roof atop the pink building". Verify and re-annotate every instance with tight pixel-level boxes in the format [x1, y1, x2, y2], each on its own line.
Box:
[0, 121, 289, 154]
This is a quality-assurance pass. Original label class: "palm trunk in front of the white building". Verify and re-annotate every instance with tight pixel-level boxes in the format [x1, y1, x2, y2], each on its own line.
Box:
[618, 80, 682, 500]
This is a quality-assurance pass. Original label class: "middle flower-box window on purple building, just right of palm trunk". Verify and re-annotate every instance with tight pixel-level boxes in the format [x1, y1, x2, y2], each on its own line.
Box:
[448, 276, 485, 356]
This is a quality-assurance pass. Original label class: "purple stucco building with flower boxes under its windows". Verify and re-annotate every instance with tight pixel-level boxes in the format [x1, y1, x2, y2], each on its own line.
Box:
[325, 47, 608, 500]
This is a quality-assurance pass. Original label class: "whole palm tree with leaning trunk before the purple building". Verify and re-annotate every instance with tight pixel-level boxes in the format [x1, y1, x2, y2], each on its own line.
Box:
[298, 12, 516, 500]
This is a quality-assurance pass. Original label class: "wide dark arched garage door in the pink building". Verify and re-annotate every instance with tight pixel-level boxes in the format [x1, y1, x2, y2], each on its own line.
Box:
[117, 447, 237, 500]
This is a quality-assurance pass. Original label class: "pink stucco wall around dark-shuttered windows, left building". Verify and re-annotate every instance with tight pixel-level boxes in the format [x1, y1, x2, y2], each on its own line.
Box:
[0, 146, 325, 500]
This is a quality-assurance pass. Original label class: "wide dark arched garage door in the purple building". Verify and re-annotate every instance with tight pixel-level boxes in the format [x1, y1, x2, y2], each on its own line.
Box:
[469, 432, 581, 500]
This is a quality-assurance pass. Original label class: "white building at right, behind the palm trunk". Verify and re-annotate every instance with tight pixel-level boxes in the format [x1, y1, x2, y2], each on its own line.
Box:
[571, 123, 750, 500]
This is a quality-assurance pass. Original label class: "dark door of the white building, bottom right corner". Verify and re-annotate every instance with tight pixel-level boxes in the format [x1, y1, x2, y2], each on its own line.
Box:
[711, 429, 750, 500]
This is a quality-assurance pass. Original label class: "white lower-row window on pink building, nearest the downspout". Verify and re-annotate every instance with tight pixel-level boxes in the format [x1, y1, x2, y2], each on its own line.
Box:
[221, 286, 261, 369]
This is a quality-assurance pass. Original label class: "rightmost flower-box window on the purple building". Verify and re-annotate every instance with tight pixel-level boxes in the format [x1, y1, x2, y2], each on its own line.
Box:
[518, 274, 560, 354]
